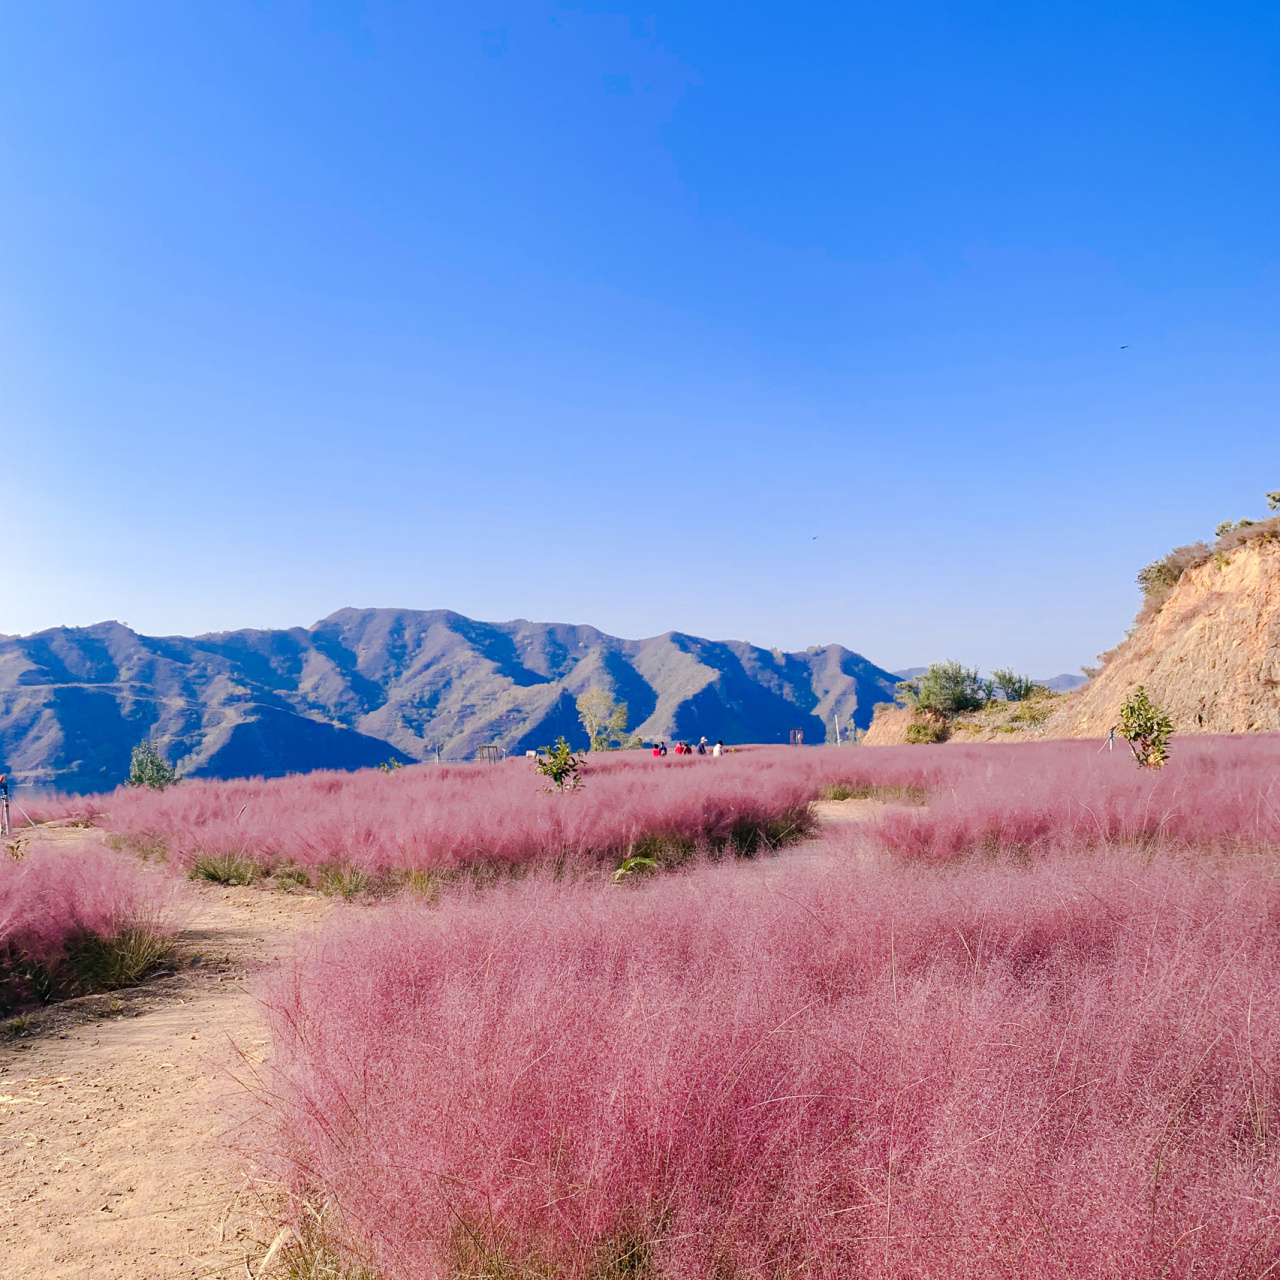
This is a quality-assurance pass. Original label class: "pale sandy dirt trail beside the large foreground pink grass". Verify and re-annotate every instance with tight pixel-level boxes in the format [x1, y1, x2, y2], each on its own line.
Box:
[0, 833, 330, 1280]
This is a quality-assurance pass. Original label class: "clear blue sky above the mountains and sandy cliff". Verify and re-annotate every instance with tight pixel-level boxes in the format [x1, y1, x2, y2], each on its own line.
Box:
[0, 0, 1280, 675]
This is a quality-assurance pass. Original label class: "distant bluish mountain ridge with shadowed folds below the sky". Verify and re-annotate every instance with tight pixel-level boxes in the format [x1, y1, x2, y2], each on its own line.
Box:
[0, 609, 895, 791]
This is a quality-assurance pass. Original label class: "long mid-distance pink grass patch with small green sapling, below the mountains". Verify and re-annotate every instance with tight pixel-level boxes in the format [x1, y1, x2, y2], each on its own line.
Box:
[77, 751, 839, 876]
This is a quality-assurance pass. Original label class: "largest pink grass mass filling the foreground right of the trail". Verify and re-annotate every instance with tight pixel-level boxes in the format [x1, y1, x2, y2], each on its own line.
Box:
[257, 854, 1280, 1280]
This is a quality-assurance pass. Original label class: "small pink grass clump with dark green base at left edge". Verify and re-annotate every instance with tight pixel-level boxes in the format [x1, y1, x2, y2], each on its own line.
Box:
[0, 845, 180, 1010]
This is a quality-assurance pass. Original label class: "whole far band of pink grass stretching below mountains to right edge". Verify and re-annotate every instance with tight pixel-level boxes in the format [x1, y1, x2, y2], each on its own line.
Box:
[28, 736, 1280, 874]
